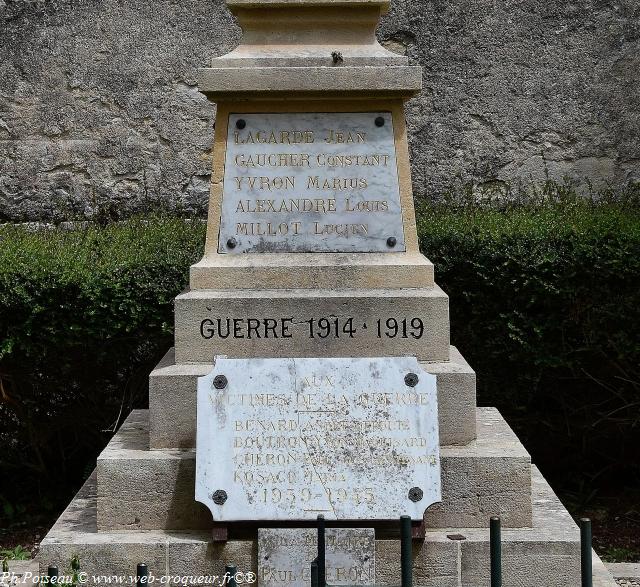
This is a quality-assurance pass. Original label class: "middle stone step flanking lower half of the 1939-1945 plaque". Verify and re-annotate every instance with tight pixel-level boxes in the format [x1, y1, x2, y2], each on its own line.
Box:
[92, 408, 531, 531]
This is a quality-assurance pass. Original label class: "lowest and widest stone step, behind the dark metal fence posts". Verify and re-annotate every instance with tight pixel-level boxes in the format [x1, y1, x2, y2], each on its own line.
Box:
[38, 467, 615, 587]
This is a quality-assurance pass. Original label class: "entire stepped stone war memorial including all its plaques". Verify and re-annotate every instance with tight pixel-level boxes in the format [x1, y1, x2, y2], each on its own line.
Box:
[33, 0, 620, 587]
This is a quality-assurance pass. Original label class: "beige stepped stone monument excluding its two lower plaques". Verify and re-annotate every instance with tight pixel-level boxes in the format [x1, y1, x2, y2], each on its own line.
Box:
[38, 0, 614, 587]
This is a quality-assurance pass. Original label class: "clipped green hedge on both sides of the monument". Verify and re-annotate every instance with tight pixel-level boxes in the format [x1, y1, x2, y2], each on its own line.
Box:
[0, 202, 640, 511]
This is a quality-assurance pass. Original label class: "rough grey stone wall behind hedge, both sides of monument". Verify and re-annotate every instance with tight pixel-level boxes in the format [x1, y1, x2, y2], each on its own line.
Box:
[0, 0, 640, 220]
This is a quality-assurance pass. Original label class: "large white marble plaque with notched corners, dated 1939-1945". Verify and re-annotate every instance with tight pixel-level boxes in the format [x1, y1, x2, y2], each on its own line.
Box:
[196, 357, 440, 521]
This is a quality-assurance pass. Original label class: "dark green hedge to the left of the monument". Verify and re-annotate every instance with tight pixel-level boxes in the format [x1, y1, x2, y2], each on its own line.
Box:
[0, 219, 204, 520]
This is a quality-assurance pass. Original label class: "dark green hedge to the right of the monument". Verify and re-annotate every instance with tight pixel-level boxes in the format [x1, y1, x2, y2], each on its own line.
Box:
[419, 199, 640, 500]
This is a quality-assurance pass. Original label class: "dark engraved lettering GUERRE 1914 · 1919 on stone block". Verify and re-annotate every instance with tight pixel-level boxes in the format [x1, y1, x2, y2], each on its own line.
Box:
[200, 316, 425, 340]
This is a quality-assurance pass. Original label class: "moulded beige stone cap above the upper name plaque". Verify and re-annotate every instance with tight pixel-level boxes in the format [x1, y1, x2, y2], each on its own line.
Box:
[199, 0, 422, 100]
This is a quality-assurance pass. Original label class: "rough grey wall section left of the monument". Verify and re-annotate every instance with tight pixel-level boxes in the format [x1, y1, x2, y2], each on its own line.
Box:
[0, 0, 239, 219]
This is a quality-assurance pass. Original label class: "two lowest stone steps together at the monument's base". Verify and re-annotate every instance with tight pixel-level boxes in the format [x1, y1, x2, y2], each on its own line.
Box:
[37, 408, 615, 587]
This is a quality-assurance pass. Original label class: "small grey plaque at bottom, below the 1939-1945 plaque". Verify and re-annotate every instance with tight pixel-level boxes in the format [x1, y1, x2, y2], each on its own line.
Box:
[258, 528, 376, 587]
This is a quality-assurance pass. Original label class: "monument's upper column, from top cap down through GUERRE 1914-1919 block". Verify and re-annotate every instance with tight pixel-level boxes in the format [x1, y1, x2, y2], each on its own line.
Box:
[176, 0, 449, 363]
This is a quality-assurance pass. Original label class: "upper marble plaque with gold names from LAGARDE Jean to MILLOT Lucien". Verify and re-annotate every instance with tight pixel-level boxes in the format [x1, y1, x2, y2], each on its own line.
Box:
[218, 112, 405, 253]
